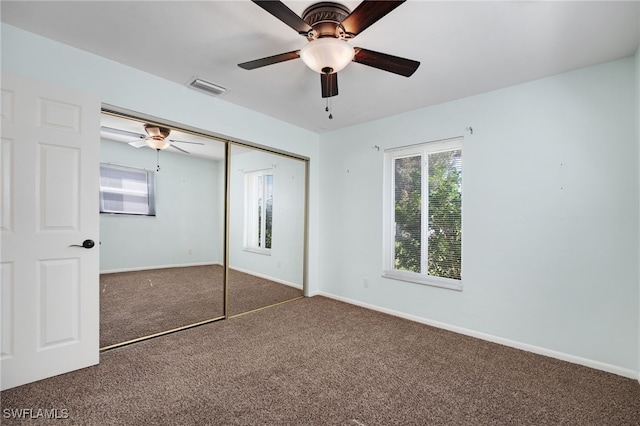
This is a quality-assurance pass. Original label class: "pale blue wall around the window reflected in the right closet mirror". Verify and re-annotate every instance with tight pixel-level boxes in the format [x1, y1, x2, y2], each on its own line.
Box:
[229, 147, 304, 286]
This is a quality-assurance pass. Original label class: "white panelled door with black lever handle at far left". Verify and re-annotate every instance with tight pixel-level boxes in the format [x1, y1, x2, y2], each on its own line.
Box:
[0, 74, 100, 390]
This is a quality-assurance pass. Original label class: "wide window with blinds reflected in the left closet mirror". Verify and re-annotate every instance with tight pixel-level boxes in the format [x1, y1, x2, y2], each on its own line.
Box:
[100, 163, 156, 216]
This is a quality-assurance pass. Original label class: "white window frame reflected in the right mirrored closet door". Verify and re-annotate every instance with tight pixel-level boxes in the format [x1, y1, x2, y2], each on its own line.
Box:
[243, 169, 273, 256]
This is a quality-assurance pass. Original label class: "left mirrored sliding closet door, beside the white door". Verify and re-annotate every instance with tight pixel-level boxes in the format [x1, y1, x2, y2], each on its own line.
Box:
[100, 113, 225, 349]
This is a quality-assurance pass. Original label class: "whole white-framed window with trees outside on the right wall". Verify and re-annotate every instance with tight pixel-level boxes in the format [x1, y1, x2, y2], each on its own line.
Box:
[383, 139, 462, 290]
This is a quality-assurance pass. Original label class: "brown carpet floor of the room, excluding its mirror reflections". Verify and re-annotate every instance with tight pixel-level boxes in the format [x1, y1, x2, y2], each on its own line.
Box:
[0, 296, 640, 426]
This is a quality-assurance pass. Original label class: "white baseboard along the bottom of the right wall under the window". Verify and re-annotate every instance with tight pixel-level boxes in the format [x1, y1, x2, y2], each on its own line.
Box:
[316, 291, 640, 382]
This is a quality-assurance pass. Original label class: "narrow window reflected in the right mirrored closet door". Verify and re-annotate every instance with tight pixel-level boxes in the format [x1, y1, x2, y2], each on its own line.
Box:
[244, 169, 273, 254]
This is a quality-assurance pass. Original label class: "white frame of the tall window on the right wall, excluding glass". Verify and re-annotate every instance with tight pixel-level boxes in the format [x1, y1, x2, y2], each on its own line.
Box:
[382, 137, 464, 291]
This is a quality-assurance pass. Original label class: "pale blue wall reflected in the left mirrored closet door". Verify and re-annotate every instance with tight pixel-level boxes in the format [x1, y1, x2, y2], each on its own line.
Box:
[100, 139, 224, 272]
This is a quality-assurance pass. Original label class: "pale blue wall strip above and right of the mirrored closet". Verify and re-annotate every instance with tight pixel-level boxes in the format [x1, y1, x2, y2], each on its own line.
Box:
[0, 23, 319, 292]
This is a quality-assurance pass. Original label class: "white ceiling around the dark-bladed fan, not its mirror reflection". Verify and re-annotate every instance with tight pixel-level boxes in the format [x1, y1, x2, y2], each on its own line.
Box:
[0, 0, 640, 133]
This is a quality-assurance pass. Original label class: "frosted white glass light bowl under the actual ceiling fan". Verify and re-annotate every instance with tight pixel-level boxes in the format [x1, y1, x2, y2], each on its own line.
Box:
[300, 37, 355, 74]
